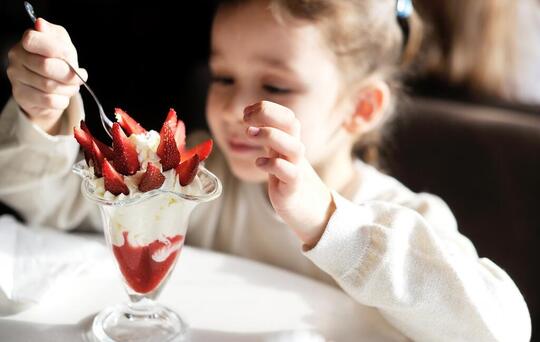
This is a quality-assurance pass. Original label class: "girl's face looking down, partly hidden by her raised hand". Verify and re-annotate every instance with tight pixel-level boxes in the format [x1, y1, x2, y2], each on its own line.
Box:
[206, 1, 348, 182]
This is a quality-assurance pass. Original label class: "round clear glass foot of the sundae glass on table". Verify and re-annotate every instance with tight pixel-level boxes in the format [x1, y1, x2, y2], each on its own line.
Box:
[92, 301, 189, 342]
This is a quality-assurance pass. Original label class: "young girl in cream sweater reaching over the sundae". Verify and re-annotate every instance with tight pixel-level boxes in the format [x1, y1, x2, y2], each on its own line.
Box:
[0, 0, 531, 341]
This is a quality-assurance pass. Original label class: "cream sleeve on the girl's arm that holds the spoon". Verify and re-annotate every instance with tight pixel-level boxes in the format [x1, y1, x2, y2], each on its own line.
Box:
[0, 96, 99, 229]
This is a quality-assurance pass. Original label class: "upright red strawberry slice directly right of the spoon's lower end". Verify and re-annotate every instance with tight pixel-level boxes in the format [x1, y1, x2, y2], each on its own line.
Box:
[112, 122, 141, 176]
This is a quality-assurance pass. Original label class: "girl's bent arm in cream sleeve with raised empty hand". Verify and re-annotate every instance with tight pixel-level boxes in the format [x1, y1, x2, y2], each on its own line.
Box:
[244, 102, 531, 341]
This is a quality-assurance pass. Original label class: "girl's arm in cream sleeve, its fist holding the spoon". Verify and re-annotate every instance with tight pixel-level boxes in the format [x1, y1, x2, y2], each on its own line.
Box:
[0, 18, 98, 229]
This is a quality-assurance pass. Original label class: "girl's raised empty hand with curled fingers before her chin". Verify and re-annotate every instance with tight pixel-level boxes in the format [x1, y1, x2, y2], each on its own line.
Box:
[244, 101, 335, 248]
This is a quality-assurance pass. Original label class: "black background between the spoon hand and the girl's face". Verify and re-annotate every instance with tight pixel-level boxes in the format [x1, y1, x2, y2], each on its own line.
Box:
[0, 0, 217, 140]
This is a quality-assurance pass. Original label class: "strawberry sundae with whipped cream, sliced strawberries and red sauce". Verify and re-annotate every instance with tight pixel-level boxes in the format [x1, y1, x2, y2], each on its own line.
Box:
[74, 108, 212, 294]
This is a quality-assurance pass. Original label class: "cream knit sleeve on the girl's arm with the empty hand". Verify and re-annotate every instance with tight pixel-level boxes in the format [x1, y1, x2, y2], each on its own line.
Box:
[305, 193, 531, 341]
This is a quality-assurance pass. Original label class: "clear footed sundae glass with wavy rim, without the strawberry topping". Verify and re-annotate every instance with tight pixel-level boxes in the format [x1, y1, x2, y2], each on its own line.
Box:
[73, 156, 221, 342]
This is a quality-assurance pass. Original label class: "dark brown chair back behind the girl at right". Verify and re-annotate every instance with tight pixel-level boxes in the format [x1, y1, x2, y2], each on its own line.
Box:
[385, 98, 540, 331]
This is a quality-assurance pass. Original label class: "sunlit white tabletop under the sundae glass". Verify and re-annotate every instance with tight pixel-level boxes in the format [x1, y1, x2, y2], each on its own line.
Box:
[0, 240, 401, 342]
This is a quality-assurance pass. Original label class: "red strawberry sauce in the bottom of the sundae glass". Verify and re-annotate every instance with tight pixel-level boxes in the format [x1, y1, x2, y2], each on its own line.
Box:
[113, 232, 184, 293]
